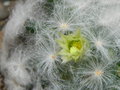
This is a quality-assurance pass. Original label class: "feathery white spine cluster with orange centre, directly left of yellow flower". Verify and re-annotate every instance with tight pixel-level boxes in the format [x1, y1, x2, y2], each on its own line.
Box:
[36, 34, 61, 80]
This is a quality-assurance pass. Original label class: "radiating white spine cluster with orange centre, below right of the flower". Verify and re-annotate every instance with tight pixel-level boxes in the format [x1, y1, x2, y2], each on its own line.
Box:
[78, 59, 116, 90]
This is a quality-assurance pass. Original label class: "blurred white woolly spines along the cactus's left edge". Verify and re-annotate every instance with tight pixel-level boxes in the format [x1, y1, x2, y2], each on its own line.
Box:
[0, 0, 43, 90]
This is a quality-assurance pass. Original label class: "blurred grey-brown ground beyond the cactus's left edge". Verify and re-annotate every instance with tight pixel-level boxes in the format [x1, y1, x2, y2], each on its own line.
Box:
[0, 0, 17, 90]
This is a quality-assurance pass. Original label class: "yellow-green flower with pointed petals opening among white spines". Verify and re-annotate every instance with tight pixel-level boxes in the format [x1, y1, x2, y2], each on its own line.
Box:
[57, 30, 88, 62]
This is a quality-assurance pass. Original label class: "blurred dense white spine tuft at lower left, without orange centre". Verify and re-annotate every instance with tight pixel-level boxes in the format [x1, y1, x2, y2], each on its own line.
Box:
[5, 50, 31, 85]
